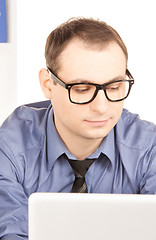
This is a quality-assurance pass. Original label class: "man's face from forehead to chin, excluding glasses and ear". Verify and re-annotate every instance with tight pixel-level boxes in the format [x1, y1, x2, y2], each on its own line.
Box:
[51, 39, 126, 141]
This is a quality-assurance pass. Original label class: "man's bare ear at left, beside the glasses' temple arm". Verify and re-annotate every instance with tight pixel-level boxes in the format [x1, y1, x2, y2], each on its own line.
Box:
[39, 68, 52, 100]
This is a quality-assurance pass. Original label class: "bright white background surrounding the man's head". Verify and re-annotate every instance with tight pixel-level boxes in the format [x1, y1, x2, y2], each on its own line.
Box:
[0, 0, 156, 123]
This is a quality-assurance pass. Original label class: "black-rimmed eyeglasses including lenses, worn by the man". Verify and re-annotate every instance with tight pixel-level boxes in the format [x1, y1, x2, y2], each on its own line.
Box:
[48, 68, 134, 104]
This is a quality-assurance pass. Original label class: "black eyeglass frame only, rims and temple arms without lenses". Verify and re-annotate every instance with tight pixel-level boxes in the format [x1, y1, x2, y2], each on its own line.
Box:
[47, 68, 134, 105]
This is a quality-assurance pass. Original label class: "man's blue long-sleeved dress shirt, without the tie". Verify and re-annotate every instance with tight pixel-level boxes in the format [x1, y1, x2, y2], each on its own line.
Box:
[0, 101, 156, 240]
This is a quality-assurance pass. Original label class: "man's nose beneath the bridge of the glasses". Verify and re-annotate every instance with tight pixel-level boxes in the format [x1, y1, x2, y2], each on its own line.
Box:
[90, 89, 109, 114]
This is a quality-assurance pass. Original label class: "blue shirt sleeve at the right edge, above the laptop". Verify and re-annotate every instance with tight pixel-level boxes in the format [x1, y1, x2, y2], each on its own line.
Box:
[139, 146, 156, 194]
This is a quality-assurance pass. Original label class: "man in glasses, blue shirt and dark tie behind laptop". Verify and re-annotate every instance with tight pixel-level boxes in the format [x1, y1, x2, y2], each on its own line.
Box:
[0, 18, 156, 240]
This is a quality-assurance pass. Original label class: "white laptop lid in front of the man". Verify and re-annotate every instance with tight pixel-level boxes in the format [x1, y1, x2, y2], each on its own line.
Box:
[29, 193, 156, 240]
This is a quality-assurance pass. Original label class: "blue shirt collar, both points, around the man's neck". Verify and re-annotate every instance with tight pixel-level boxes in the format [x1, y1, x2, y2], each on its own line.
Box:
[47, 108, 115, 170]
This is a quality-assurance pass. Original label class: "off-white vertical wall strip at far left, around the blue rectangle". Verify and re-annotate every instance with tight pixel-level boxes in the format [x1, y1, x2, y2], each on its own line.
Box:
[0, 0, 17, 123]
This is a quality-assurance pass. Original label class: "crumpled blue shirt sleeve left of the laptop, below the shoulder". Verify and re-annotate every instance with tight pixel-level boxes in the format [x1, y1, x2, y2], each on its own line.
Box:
[0, 149, 28, 240]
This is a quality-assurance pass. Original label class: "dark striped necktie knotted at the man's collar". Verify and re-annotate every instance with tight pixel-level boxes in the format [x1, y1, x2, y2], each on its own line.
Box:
[68, 159, 95, 193]
